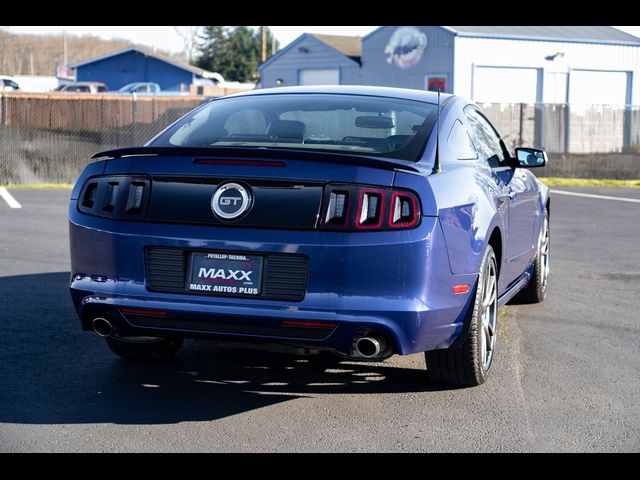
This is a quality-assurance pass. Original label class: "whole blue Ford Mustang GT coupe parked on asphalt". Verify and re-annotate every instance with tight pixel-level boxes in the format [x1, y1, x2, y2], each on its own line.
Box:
[69, 87, 549, 386]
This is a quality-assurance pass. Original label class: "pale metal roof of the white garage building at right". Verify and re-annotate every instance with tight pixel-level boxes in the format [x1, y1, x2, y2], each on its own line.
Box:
[443, 25, 640, 45]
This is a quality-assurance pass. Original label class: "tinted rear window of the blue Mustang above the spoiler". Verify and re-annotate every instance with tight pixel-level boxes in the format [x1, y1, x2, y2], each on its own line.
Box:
[151, 94, 437, 161]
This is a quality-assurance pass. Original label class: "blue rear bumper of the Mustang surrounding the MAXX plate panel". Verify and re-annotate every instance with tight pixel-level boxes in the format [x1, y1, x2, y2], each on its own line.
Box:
[70, 210, 476, 355]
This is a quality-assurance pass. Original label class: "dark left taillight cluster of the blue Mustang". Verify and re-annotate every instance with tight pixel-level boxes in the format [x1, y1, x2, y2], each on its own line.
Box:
[78, 176, 151, 220]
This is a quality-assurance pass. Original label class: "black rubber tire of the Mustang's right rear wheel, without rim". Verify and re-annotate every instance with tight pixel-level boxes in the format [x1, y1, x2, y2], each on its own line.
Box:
[425, 245, 498, 387]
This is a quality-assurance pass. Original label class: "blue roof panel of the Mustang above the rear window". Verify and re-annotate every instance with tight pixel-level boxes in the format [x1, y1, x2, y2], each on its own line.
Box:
[225, 85, 453, 104]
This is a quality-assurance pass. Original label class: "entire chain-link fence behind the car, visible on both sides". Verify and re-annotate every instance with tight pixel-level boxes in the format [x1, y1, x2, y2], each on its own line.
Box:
[0, 93, 640, 185]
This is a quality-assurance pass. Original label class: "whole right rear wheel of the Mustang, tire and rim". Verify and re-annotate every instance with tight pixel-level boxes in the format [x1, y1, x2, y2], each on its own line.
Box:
[425, 245, 498, 387]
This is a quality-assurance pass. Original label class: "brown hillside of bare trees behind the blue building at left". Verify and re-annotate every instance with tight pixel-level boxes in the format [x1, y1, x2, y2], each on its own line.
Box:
[0, 30, 185, 75]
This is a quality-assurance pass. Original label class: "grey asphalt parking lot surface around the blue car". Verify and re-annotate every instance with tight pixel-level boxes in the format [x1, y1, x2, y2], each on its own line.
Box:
[0, 188, 640, 452]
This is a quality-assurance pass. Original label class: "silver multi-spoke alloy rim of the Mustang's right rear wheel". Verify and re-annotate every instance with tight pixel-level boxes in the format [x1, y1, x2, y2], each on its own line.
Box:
[479, 258, 498, 372]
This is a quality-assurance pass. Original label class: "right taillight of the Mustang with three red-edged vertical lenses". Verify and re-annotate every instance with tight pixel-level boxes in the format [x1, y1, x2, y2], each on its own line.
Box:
[318, 185, 420, 231]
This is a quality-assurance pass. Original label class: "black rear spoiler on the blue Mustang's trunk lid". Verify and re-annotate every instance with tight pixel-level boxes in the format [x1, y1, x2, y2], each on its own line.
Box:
[91, 147, 421, 173]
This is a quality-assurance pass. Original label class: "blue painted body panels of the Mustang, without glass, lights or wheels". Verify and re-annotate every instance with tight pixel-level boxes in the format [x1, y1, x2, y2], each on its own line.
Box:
[69, 87, 548, 355]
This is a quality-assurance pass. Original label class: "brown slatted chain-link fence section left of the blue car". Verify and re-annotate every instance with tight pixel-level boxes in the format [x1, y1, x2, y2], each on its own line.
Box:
[0, 93, 206, 185]
